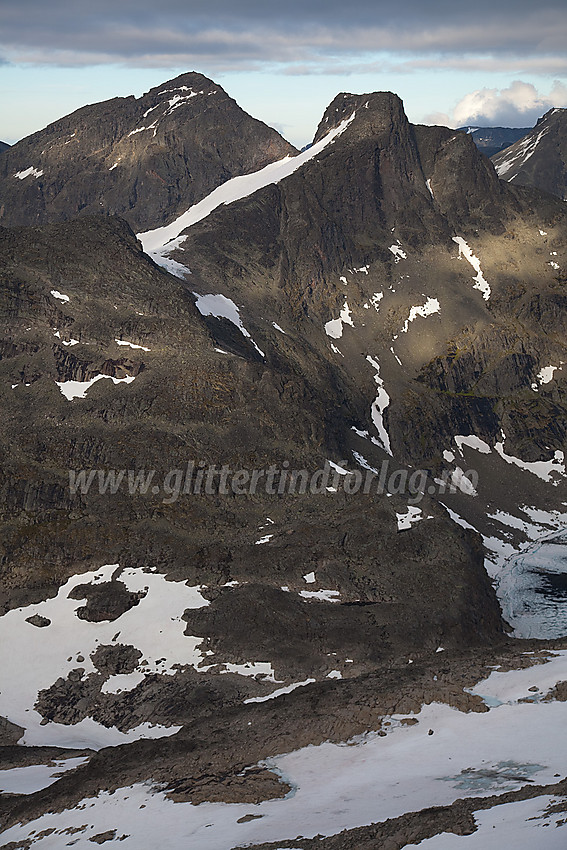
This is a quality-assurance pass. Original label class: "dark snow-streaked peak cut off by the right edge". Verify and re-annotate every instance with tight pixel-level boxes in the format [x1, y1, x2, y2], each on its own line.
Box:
[492, 109, 567, 200]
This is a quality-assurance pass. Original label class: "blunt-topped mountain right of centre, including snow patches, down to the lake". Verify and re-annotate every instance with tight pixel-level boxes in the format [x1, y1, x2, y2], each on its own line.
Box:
[150, 89, 567, 634]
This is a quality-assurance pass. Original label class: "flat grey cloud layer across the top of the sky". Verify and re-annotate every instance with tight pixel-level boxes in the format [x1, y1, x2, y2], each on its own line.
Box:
[0, 0, 567, 69]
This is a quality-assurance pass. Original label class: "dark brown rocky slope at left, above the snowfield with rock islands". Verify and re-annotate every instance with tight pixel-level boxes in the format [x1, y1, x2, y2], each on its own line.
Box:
[0, 212, 506, 656]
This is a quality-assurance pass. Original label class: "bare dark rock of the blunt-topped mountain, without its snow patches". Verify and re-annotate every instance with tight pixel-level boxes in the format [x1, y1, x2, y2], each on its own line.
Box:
[172, 93, 567, 480]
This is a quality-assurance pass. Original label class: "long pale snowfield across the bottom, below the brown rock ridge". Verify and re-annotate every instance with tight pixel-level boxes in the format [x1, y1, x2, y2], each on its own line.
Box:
[2, 652, 567, 850]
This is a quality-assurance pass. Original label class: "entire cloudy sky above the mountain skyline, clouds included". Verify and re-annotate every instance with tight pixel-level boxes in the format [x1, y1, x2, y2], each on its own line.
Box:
[0, 0, 567, 146]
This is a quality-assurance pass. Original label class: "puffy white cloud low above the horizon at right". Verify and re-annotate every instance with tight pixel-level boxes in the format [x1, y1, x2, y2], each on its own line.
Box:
[454, 80, 567, 127]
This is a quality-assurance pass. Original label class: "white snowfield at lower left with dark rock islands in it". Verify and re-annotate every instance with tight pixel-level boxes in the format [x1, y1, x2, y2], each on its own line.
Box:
[0, 564, 284, 749]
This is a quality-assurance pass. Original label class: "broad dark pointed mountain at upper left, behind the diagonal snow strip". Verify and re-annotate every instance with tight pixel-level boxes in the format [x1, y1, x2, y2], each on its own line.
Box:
[0, 73, 297, 231]
